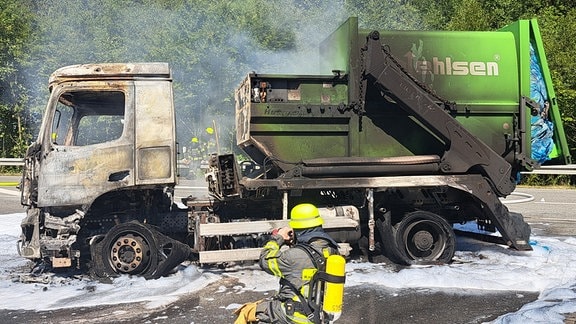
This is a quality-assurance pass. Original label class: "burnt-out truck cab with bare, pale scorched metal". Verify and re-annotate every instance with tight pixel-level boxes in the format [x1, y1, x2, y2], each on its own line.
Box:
[19, 63, 188, 278]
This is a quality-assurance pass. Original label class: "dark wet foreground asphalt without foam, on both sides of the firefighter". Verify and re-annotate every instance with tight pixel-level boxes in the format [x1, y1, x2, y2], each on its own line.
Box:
[0, 279, 538, 324]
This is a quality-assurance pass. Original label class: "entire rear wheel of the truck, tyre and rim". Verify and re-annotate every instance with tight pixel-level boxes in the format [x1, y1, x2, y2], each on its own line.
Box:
[395, 211, 456, 264]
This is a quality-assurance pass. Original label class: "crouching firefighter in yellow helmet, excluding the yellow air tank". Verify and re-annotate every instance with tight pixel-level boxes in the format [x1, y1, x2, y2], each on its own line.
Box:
[235, 204, 338, 324]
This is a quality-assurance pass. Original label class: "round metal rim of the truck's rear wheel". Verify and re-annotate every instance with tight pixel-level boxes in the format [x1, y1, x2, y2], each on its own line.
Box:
[403, 220, 447, 261]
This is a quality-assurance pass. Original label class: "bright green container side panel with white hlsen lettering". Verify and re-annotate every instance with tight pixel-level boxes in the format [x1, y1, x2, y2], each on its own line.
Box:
[368, 31, 518, 113]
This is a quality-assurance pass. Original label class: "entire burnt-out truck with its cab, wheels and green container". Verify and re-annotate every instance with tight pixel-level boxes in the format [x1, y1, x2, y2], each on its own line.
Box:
[19, 18, 570, 278]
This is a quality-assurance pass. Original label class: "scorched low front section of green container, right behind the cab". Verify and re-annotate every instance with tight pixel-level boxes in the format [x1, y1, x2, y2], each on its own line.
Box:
[236, 74, 351, 165]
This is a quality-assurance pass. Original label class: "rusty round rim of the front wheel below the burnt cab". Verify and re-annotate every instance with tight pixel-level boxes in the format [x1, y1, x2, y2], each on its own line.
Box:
[110, 234, 150, 273]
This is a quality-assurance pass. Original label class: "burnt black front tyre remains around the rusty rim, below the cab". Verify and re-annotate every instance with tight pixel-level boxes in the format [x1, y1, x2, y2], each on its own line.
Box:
[90, 221, 190, 279]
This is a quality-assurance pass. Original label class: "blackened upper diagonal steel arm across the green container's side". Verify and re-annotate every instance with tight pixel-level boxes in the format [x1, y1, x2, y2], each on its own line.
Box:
[363, 31, 516, 197]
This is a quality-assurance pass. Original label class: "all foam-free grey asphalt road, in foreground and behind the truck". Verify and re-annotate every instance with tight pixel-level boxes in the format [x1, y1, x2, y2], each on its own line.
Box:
[0, 177, 576, 323]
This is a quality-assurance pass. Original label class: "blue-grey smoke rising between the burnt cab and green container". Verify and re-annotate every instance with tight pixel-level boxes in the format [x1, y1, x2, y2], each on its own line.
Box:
[122, 0, 346, 152]
